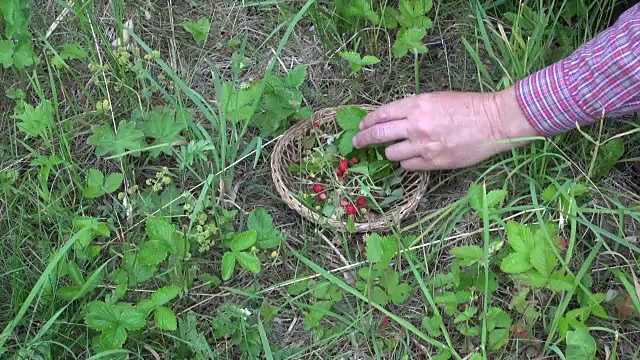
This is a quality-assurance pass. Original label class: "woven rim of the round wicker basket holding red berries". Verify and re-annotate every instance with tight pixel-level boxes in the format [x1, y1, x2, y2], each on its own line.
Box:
[271, 104, 429, 233]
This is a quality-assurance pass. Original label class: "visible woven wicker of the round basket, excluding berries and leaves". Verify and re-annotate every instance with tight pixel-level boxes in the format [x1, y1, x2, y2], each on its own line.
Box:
[271, 105, 428, 233]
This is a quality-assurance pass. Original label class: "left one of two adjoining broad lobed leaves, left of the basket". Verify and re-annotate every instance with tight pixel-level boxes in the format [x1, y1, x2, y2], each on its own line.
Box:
[87, 121, 146, 156]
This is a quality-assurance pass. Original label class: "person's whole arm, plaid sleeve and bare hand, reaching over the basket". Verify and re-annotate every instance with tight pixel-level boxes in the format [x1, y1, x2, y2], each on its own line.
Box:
[353, 4, 640, 170]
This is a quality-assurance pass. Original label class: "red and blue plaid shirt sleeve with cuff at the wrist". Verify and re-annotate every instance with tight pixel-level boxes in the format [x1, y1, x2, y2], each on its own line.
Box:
[516, 4, 640, 136]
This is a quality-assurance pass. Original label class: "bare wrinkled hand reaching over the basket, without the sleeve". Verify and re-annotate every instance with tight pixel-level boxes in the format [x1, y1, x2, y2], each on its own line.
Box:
[353, 88, 537, 170]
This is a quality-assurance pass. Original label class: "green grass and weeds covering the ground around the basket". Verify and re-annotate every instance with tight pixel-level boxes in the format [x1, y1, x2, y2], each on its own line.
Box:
[0, 0, 640, 359]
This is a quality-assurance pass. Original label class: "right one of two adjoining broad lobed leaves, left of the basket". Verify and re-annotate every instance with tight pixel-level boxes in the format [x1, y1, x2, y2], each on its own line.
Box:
[140, 107, 187, 158]
